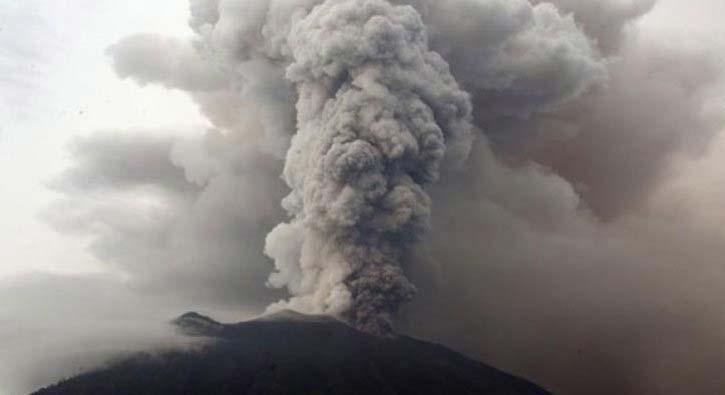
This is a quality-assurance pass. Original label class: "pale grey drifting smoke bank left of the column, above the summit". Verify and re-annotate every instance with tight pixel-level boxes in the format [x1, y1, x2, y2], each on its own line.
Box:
[43, 131, 283, 309]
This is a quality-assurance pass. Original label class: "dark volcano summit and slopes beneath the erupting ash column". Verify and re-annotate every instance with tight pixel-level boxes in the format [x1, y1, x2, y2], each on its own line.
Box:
[29, 311, 549, 395]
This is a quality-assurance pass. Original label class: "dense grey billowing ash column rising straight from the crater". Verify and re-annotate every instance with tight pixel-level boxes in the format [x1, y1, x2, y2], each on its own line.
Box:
[266, 0, 472, 334]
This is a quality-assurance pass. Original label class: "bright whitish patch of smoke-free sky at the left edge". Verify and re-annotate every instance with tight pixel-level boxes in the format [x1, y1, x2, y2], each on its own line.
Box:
[0, 0, 205, 277]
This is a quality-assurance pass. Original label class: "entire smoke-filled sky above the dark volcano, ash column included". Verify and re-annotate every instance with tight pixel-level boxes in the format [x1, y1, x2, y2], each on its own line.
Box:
[0, 0, 725, 395]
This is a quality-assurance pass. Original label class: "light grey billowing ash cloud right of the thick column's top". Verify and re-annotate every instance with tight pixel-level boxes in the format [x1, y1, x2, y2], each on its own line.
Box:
[417, 0, 607, 122]
